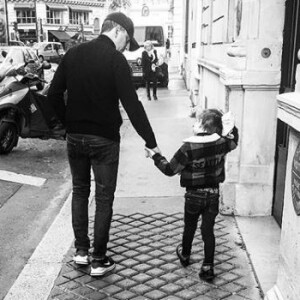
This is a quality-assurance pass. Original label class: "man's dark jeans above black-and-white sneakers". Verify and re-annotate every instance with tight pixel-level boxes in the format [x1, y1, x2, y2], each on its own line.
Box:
[67, 134, 120, 259]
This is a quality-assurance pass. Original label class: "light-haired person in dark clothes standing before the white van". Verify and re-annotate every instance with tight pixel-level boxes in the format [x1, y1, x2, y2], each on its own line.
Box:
[142, 41, 158, 101]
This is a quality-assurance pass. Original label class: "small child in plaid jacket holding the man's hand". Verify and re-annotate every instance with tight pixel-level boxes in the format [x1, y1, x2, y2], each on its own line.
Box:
[146, 109, 238, 281]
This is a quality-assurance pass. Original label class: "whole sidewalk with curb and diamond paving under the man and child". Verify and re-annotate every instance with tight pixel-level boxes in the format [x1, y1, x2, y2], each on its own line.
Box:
[5, 74, 262, 300]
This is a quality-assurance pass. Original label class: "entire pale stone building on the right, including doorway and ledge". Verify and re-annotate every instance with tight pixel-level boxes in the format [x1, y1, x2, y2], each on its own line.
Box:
[181, 0, 300, 300]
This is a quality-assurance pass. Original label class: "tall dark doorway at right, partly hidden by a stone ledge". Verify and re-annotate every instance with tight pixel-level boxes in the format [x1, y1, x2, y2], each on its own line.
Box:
[272, 0, 300, 227]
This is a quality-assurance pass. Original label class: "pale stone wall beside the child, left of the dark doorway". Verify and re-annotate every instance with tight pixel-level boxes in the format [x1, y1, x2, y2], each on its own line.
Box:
[189, 0, 285, 216]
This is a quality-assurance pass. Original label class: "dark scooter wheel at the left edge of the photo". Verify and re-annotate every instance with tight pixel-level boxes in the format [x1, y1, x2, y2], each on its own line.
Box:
[0, 122, 19, 154]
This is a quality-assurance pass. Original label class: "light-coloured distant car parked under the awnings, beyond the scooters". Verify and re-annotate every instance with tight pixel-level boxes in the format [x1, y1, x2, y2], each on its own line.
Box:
[33, 42, 65, 63]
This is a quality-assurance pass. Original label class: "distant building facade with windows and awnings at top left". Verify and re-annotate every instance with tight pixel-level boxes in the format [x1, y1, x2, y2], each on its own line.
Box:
[7, 0, 108, 43]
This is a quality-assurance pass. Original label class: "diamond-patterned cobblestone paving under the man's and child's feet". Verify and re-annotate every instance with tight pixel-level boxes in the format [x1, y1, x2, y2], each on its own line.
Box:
[48, 213, 262, 300]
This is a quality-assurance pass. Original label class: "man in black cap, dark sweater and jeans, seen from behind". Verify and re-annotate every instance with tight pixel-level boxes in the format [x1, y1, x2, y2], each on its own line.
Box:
[48, 12, 159, 276]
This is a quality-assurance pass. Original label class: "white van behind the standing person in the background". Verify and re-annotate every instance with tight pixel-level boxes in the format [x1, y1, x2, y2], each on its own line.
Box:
[123, 25, 169, 87]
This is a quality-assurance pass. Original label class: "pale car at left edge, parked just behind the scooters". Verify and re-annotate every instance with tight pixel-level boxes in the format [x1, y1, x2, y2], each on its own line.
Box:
[0, 46, 44, 89]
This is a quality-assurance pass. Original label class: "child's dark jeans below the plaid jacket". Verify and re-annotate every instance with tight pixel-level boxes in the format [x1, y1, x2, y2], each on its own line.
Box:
[182, 190, 219, 265]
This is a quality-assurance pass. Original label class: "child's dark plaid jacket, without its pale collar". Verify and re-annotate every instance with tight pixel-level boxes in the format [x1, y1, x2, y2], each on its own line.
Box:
[153, 127, 238, 187]
